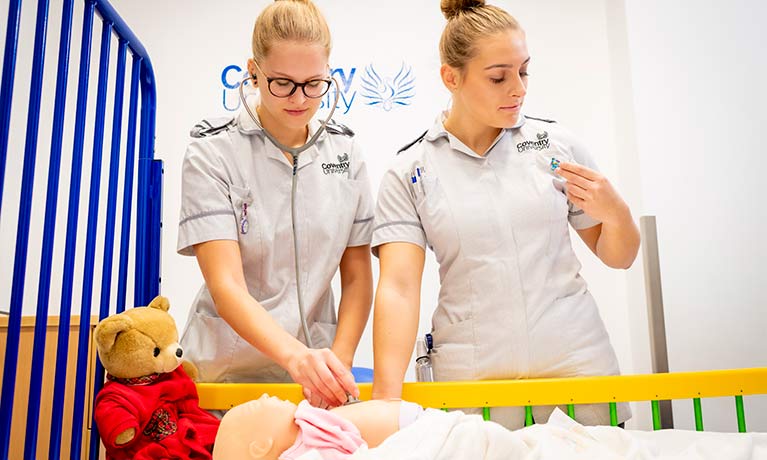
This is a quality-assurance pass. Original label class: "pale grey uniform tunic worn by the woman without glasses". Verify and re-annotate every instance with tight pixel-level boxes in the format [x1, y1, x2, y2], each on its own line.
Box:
[372, 114, 630, 428]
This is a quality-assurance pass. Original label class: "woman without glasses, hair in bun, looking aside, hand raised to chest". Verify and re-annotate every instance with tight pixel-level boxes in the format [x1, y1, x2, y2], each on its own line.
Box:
[372, 0, 639, 428]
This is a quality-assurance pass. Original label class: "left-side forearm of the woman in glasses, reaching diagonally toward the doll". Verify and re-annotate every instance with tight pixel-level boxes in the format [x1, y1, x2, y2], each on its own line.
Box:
[208, 282, 305, 368]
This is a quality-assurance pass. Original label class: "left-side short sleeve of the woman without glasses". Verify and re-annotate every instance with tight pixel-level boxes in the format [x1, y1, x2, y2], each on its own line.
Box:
[372, 164, 426, 257]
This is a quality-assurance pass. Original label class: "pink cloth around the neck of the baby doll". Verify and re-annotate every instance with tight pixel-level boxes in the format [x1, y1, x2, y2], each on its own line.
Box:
[279, 401, 367, 460]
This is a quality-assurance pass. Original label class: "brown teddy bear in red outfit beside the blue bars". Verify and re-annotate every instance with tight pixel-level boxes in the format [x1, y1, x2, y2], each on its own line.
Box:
[93, 296, 219, 460]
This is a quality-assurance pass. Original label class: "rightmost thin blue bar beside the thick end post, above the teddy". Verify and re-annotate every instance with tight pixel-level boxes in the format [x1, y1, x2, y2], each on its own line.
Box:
[116, 56, 141, 313]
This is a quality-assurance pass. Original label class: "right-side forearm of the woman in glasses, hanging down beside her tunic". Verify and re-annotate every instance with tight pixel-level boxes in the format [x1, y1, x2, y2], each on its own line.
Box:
[333, 270, 373, 368]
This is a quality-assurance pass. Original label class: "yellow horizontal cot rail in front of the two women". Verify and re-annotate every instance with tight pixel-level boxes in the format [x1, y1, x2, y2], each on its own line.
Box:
[197, 367, 767, 431]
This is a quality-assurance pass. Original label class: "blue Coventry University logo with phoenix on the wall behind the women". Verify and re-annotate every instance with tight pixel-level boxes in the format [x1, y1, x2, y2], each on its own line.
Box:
[221, 62, 415, 115]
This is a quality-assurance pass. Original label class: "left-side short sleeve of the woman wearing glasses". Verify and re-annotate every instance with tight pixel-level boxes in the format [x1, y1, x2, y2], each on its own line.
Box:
[176, 139, 237, 256]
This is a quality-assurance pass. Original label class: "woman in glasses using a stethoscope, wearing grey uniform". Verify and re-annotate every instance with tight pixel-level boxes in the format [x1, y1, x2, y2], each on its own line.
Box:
[178, 0, 373, 406]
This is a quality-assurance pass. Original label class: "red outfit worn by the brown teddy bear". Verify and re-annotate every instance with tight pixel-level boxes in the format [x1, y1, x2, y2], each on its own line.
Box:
[94, 366, 220, 460]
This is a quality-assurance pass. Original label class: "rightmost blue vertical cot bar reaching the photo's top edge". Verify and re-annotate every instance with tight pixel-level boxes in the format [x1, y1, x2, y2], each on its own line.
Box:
[48, 1, 94, 458]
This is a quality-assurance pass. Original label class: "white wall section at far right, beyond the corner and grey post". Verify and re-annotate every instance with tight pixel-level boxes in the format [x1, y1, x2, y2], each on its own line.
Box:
[626, 0, 767, 431]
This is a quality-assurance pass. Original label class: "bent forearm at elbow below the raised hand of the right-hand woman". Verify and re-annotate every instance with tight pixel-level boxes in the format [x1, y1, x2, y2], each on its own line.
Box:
[596, 206, 639, 268]
